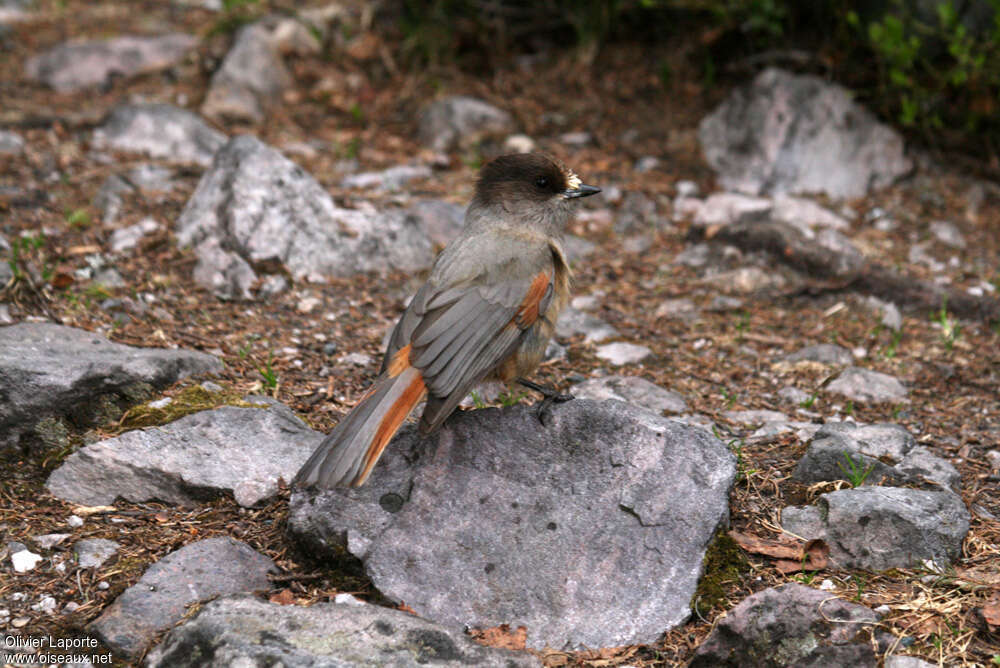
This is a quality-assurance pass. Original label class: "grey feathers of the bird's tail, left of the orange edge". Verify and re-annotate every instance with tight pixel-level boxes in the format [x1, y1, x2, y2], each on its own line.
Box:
[292, 370, 415, 489]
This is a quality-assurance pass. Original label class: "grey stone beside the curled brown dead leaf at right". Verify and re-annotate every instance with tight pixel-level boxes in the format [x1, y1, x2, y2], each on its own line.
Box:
[781, 487, 970, 571]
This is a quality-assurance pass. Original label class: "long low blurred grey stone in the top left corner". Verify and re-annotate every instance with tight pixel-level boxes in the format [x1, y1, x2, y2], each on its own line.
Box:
[24, 33, 198, 93]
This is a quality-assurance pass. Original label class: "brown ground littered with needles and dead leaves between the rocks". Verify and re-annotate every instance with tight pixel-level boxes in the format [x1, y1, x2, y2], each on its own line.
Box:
[0, 0, 1000, 666]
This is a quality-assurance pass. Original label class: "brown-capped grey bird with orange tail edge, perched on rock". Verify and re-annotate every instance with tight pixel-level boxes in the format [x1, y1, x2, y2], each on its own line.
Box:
[293, 153, 600, 488]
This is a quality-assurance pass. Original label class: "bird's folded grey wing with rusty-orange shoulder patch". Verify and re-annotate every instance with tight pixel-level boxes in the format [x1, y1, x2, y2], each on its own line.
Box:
[383, 235, 555, 431]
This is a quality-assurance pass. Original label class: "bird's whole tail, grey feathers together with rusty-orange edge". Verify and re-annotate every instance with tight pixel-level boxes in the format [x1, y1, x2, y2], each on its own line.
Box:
[292, 364, 427, 489]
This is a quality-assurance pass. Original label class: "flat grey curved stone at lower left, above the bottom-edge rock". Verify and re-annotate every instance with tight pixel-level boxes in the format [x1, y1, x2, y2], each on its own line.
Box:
[87, 536, 275, 659]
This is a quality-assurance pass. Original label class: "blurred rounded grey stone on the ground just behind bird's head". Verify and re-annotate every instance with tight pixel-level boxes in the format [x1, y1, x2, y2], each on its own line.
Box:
[419, 95, 514, 151]
